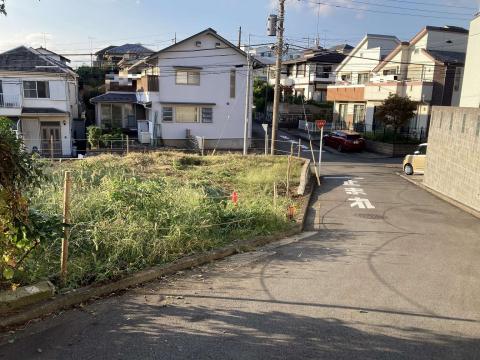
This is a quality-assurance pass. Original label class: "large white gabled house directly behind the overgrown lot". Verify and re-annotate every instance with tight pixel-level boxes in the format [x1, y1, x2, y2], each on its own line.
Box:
[91, 28, 253, 149]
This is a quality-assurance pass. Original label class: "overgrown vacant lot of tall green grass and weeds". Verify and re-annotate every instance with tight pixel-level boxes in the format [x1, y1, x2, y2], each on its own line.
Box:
[23, 152, 302, 287]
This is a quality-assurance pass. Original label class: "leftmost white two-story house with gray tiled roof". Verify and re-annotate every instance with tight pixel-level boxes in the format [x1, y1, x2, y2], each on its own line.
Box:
[0, 46, 78, 157]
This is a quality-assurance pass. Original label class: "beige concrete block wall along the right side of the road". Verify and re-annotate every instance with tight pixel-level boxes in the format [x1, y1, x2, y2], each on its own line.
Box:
[424, 106, 480, 211]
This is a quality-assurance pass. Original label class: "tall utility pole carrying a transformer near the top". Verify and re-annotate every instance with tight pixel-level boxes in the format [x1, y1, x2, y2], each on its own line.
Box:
[271, 0, 285, 155]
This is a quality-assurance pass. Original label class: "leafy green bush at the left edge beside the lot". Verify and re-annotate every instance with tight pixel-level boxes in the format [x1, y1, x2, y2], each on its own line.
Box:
[0, 117, 61, 288]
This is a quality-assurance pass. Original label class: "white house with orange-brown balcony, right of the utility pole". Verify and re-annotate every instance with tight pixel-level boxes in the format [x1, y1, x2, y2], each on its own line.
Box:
[327, 34, 400, 129]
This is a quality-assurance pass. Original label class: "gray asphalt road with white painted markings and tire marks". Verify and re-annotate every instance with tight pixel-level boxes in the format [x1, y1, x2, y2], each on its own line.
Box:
[0, 148, 480, 359]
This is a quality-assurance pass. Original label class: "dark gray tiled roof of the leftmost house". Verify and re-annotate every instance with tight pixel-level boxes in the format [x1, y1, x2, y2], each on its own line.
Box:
[0, 46, 72, 73]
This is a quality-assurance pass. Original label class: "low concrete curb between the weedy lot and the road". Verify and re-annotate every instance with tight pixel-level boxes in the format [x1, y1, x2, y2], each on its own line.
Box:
[0, 179, 313, 330]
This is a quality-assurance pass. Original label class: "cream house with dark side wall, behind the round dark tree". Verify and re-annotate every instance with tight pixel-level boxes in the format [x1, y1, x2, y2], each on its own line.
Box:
[365, 26, 468, 138]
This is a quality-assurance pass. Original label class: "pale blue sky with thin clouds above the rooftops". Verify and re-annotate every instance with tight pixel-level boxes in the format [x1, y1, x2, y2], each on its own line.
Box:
[0, 0, 480, 67]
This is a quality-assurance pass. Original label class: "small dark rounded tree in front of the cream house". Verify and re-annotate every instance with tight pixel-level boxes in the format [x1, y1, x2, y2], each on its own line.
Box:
[375, 94, 418, 134]
